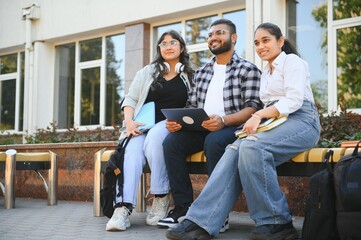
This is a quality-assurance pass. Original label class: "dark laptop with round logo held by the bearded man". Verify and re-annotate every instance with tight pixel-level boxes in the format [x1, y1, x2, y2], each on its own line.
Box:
[161, 108, 209, 131]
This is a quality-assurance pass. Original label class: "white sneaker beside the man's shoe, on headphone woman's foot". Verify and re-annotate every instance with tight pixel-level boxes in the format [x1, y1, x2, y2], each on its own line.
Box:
[146, 194, 170, 226]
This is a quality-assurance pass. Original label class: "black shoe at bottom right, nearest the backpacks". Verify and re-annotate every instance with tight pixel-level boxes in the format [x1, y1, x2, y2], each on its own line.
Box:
[251, 222, 298, 240]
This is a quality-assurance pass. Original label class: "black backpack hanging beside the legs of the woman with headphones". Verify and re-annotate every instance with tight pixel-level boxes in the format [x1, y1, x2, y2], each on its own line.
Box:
[100, 135, 132, 218]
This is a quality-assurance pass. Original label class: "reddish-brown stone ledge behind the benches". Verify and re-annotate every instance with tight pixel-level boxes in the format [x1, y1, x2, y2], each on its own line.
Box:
[0, 141, 308, 216]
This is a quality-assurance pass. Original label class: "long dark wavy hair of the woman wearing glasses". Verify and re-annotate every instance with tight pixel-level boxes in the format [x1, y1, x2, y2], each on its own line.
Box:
[152, 30, 193, 86]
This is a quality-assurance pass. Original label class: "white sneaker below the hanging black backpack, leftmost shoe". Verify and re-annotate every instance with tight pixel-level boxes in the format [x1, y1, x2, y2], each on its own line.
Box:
[105, 206, 130, 231]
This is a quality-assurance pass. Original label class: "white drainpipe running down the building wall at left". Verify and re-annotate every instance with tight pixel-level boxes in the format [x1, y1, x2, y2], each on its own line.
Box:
[22, 3, 40, 139]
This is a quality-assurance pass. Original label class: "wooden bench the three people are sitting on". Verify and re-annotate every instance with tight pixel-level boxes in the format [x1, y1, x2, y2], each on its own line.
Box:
[93, 145, 353, 216]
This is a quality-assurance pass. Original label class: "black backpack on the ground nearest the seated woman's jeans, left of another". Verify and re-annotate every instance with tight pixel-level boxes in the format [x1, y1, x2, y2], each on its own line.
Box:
[302, 150, 339, 240]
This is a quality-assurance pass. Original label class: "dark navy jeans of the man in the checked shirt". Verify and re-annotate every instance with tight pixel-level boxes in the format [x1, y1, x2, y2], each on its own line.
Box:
[163, 127, 236, 206]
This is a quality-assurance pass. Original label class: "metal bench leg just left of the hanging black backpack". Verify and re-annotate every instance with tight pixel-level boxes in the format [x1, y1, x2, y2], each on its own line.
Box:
[93, 149, 105, 217]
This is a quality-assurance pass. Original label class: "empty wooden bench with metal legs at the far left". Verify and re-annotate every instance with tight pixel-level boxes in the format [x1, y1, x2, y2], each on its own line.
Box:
[0, 149, 58, 208]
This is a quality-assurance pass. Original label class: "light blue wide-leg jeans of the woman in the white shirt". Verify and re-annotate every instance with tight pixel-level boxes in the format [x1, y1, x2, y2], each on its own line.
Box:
[186, 101, 320, 235]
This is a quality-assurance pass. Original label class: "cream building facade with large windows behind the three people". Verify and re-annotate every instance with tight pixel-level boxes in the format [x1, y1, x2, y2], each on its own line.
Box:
[0, 0, 361, 134]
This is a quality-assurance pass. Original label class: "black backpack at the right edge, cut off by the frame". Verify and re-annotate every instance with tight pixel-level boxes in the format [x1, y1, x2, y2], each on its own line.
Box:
[334, 141, 361, 240]
